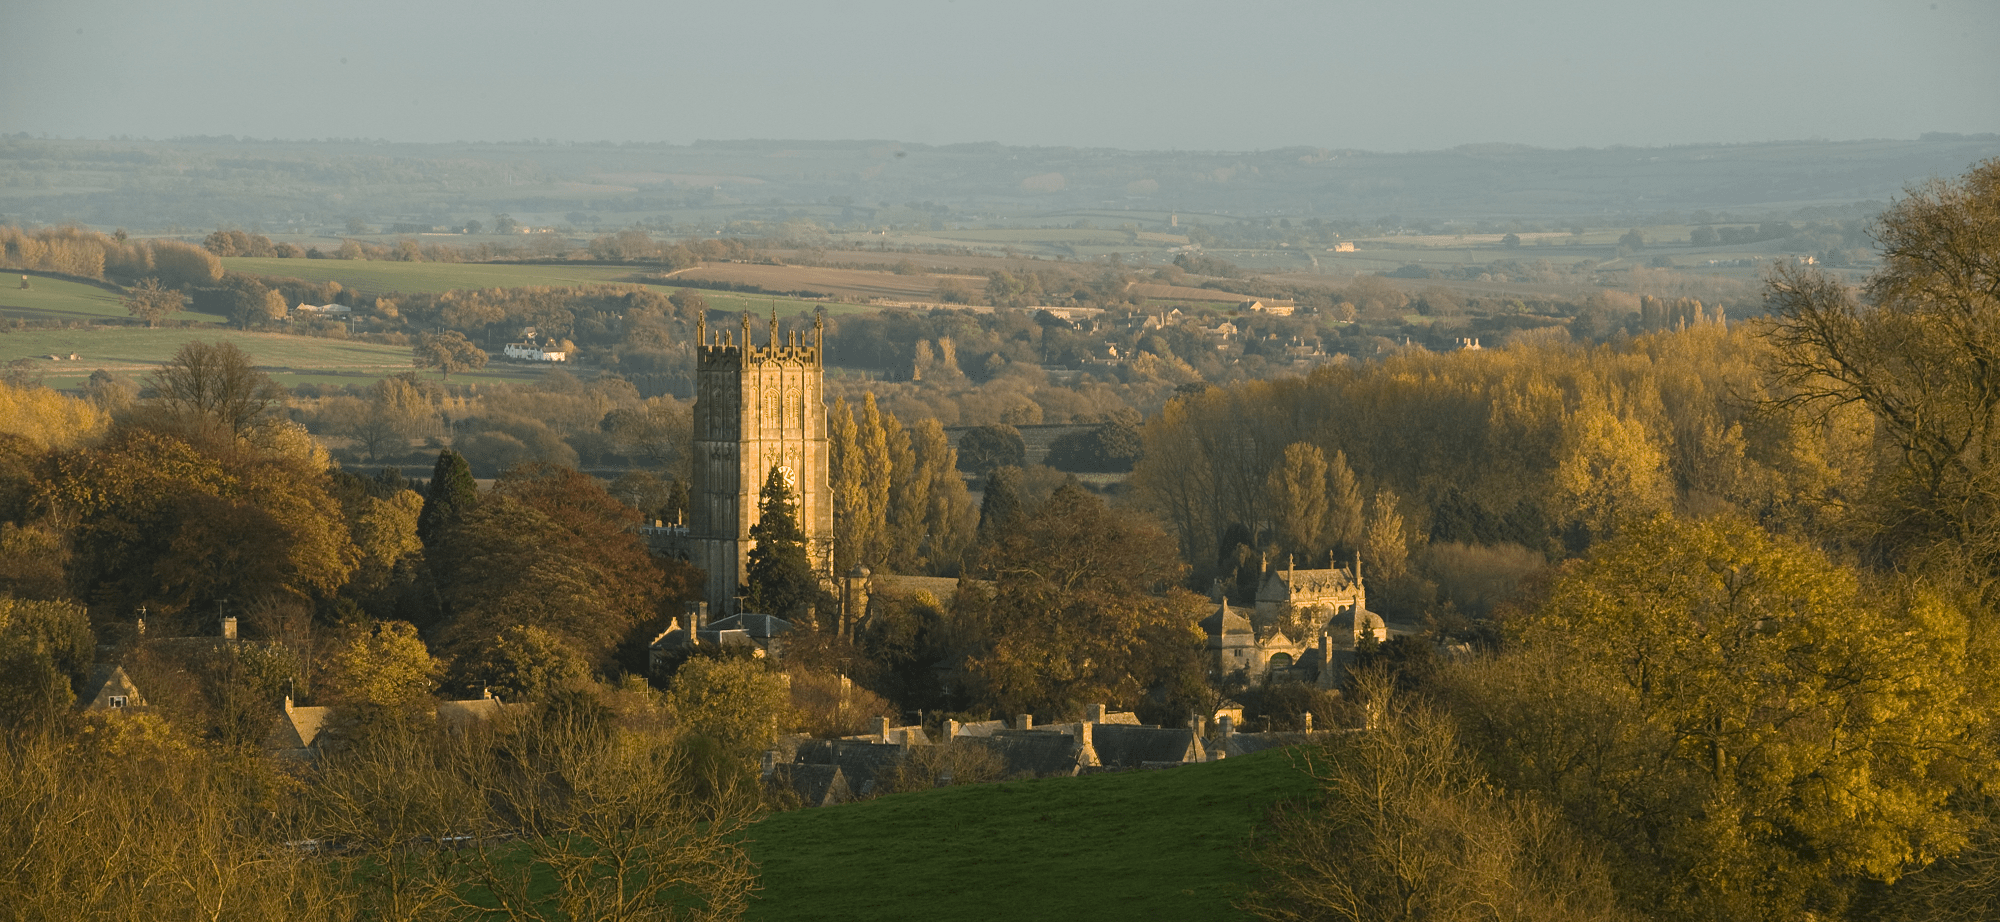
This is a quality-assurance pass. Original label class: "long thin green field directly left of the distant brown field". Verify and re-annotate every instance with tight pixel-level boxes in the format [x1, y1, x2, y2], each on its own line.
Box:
[222, 256, 640, 296]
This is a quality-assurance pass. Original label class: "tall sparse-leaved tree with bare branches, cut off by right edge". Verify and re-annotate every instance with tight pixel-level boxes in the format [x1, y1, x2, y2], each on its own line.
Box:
[1766, 160, 2000, 586]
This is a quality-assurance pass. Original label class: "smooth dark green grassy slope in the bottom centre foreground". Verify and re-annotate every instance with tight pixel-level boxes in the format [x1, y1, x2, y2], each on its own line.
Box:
[748, 750, 1310, 922]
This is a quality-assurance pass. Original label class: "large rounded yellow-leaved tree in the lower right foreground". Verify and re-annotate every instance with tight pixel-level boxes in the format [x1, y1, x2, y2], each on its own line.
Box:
[1488, 518, 1990, 918]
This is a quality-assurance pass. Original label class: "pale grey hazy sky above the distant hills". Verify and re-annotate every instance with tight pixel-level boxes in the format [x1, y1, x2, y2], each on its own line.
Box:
[0, 0, 2000, 150]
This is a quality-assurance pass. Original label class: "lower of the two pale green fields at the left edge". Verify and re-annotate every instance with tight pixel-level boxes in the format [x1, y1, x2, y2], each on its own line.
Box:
[0, 326, 540, 390]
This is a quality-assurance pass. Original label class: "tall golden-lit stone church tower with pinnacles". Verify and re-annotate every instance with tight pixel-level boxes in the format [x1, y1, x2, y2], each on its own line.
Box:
[688, 310, 834, 616]
